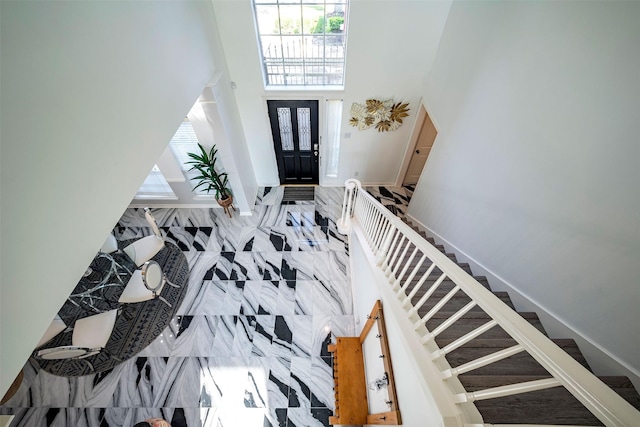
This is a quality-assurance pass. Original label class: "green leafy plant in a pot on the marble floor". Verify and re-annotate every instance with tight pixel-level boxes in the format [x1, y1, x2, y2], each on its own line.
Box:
[187, 144, 235, 217]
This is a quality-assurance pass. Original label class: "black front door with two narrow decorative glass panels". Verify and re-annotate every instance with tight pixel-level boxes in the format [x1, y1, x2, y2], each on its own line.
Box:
[267, 101, 319, 184]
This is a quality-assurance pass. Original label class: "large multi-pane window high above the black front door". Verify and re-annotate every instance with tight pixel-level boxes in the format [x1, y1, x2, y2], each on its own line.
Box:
[254, 0, 348, 87]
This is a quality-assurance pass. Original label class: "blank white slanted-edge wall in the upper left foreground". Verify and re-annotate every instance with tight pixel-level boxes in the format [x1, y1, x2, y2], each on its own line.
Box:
[0, 1, 220, 395]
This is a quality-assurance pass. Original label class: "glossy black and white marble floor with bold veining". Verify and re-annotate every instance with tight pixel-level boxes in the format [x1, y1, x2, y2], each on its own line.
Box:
[0, 187, 412, 427]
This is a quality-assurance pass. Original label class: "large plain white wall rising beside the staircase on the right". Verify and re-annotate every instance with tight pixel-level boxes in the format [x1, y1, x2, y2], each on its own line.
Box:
[409, 2, 640, 382]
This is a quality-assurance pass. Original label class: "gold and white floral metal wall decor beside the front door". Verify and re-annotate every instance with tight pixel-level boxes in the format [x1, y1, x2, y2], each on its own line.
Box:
[349, 99, 409, 132]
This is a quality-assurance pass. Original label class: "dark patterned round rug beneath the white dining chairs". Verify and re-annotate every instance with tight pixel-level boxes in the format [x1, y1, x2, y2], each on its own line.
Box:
[33, 239, 189, 377]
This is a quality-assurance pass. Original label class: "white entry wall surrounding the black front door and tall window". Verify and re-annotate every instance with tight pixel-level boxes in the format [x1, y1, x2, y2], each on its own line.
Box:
[213, 0, 450, 185]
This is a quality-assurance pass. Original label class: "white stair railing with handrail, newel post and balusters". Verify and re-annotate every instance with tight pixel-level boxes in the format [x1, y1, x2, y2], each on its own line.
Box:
[337, 179, 640, 427]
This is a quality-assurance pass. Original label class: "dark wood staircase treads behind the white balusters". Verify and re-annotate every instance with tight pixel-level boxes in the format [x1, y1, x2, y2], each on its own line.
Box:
[397, 220, 640, 426]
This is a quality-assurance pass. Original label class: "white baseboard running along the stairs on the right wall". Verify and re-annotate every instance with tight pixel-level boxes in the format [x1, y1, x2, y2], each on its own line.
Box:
[406, 214, 640, 390]
